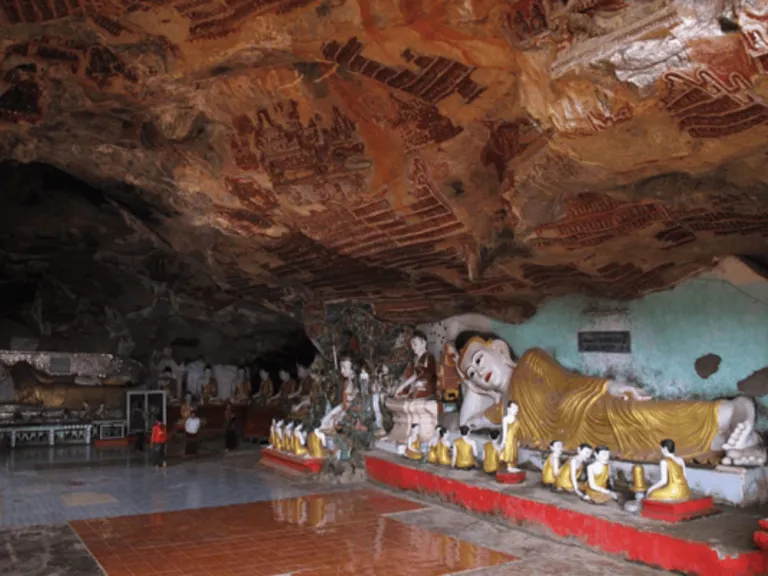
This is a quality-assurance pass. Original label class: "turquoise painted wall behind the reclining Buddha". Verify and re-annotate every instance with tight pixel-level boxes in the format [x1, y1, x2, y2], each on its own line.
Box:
[494, 276, 768, 427]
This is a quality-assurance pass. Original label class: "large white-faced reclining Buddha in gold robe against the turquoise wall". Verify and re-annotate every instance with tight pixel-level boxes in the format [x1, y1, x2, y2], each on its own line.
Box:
[456, 333, 765, 464]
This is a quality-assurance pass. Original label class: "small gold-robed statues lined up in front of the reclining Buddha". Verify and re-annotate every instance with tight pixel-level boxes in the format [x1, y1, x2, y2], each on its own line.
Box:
[404, 402, 691, 504]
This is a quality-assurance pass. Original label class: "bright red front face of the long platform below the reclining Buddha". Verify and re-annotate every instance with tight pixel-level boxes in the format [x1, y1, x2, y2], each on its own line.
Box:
[365, 455, 768, 576]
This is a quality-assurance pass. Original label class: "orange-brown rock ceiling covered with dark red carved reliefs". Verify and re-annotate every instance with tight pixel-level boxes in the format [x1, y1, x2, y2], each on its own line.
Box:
[0, 0, 768, 323]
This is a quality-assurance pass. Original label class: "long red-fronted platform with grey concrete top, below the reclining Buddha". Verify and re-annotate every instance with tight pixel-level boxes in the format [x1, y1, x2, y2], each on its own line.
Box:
[366, 450, 768, 576]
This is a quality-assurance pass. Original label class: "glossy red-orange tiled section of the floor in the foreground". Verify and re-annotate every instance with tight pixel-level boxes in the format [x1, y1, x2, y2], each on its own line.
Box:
[71, 489, 516, 576]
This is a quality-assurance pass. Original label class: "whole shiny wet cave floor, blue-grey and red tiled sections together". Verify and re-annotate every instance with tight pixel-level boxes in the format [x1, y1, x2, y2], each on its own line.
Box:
[0, 449, 658, 576]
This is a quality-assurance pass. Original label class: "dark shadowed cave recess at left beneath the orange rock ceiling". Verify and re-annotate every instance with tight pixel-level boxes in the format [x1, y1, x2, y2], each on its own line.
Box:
[0, 161, 315, 378]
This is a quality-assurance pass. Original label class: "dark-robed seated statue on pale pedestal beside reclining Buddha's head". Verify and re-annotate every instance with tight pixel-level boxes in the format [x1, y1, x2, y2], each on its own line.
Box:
[385, 331, 437, 444]
